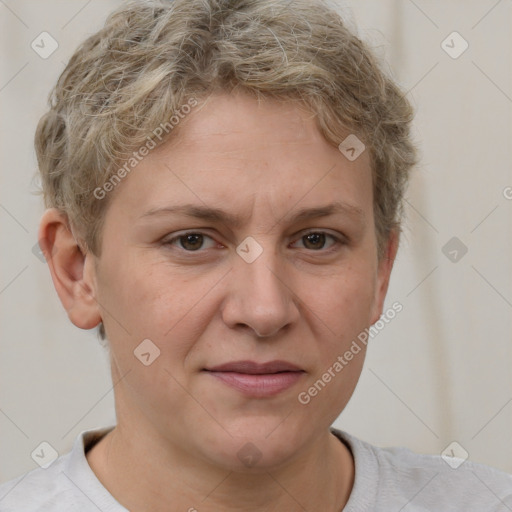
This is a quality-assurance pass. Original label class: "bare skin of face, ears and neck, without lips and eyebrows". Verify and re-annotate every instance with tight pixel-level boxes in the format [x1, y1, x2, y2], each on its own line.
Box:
[39, 93, 398, 512]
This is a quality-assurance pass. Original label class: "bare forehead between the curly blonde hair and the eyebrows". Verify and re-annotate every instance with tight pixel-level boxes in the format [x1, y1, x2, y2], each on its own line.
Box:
[109, 94, 372, 226]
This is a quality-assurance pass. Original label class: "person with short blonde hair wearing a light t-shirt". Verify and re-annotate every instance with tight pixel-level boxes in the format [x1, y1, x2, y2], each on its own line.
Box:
[0, 0, 512, 512]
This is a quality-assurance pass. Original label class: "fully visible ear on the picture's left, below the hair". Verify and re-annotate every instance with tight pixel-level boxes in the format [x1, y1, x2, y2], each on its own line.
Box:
[38, 208, 101, 329]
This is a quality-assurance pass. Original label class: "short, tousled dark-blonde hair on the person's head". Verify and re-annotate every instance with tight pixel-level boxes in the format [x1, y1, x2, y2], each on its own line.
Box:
[35, 0, 415, 336]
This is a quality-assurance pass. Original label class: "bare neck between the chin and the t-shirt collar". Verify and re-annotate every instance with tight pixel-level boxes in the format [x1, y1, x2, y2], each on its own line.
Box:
[87, 423, 354, 512]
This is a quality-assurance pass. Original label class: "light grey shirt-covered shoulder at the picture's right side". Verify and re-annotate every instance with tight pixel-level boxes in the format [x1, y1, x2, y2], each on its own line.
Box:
[332, 429, 512, 512]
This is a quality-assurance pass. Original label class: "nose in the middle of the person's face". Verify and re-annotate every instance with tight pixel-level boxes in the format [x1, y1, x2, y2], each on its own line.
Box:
[222, 245, 299, 338]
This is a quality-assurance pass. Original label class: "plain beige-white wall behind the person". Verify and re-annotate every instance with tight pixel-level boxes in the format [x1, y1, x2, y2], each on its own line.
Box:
[0, 0, 512, 481]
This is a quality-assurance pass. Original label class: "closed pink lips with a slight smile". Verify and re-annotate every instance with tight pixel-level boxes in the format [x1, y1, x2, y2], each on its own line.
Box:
[204, 361, 306, 398]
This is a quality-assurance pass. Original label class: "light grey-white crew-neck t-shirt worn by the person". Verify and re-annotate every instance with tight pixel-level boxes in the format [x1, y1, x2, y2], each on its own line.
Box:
[0, 426, 512, 512]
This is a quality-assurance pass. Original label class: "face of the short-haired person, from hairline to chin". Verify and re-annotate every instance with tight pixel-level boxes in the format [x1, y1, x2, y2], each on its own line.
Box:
[82, 94, 390, 468]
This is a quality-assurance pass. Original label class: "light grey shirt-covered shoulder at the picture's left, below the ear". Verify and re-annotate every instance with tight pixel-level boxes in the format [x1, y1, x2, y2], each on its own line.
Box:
[0, 427, 117, 512]
